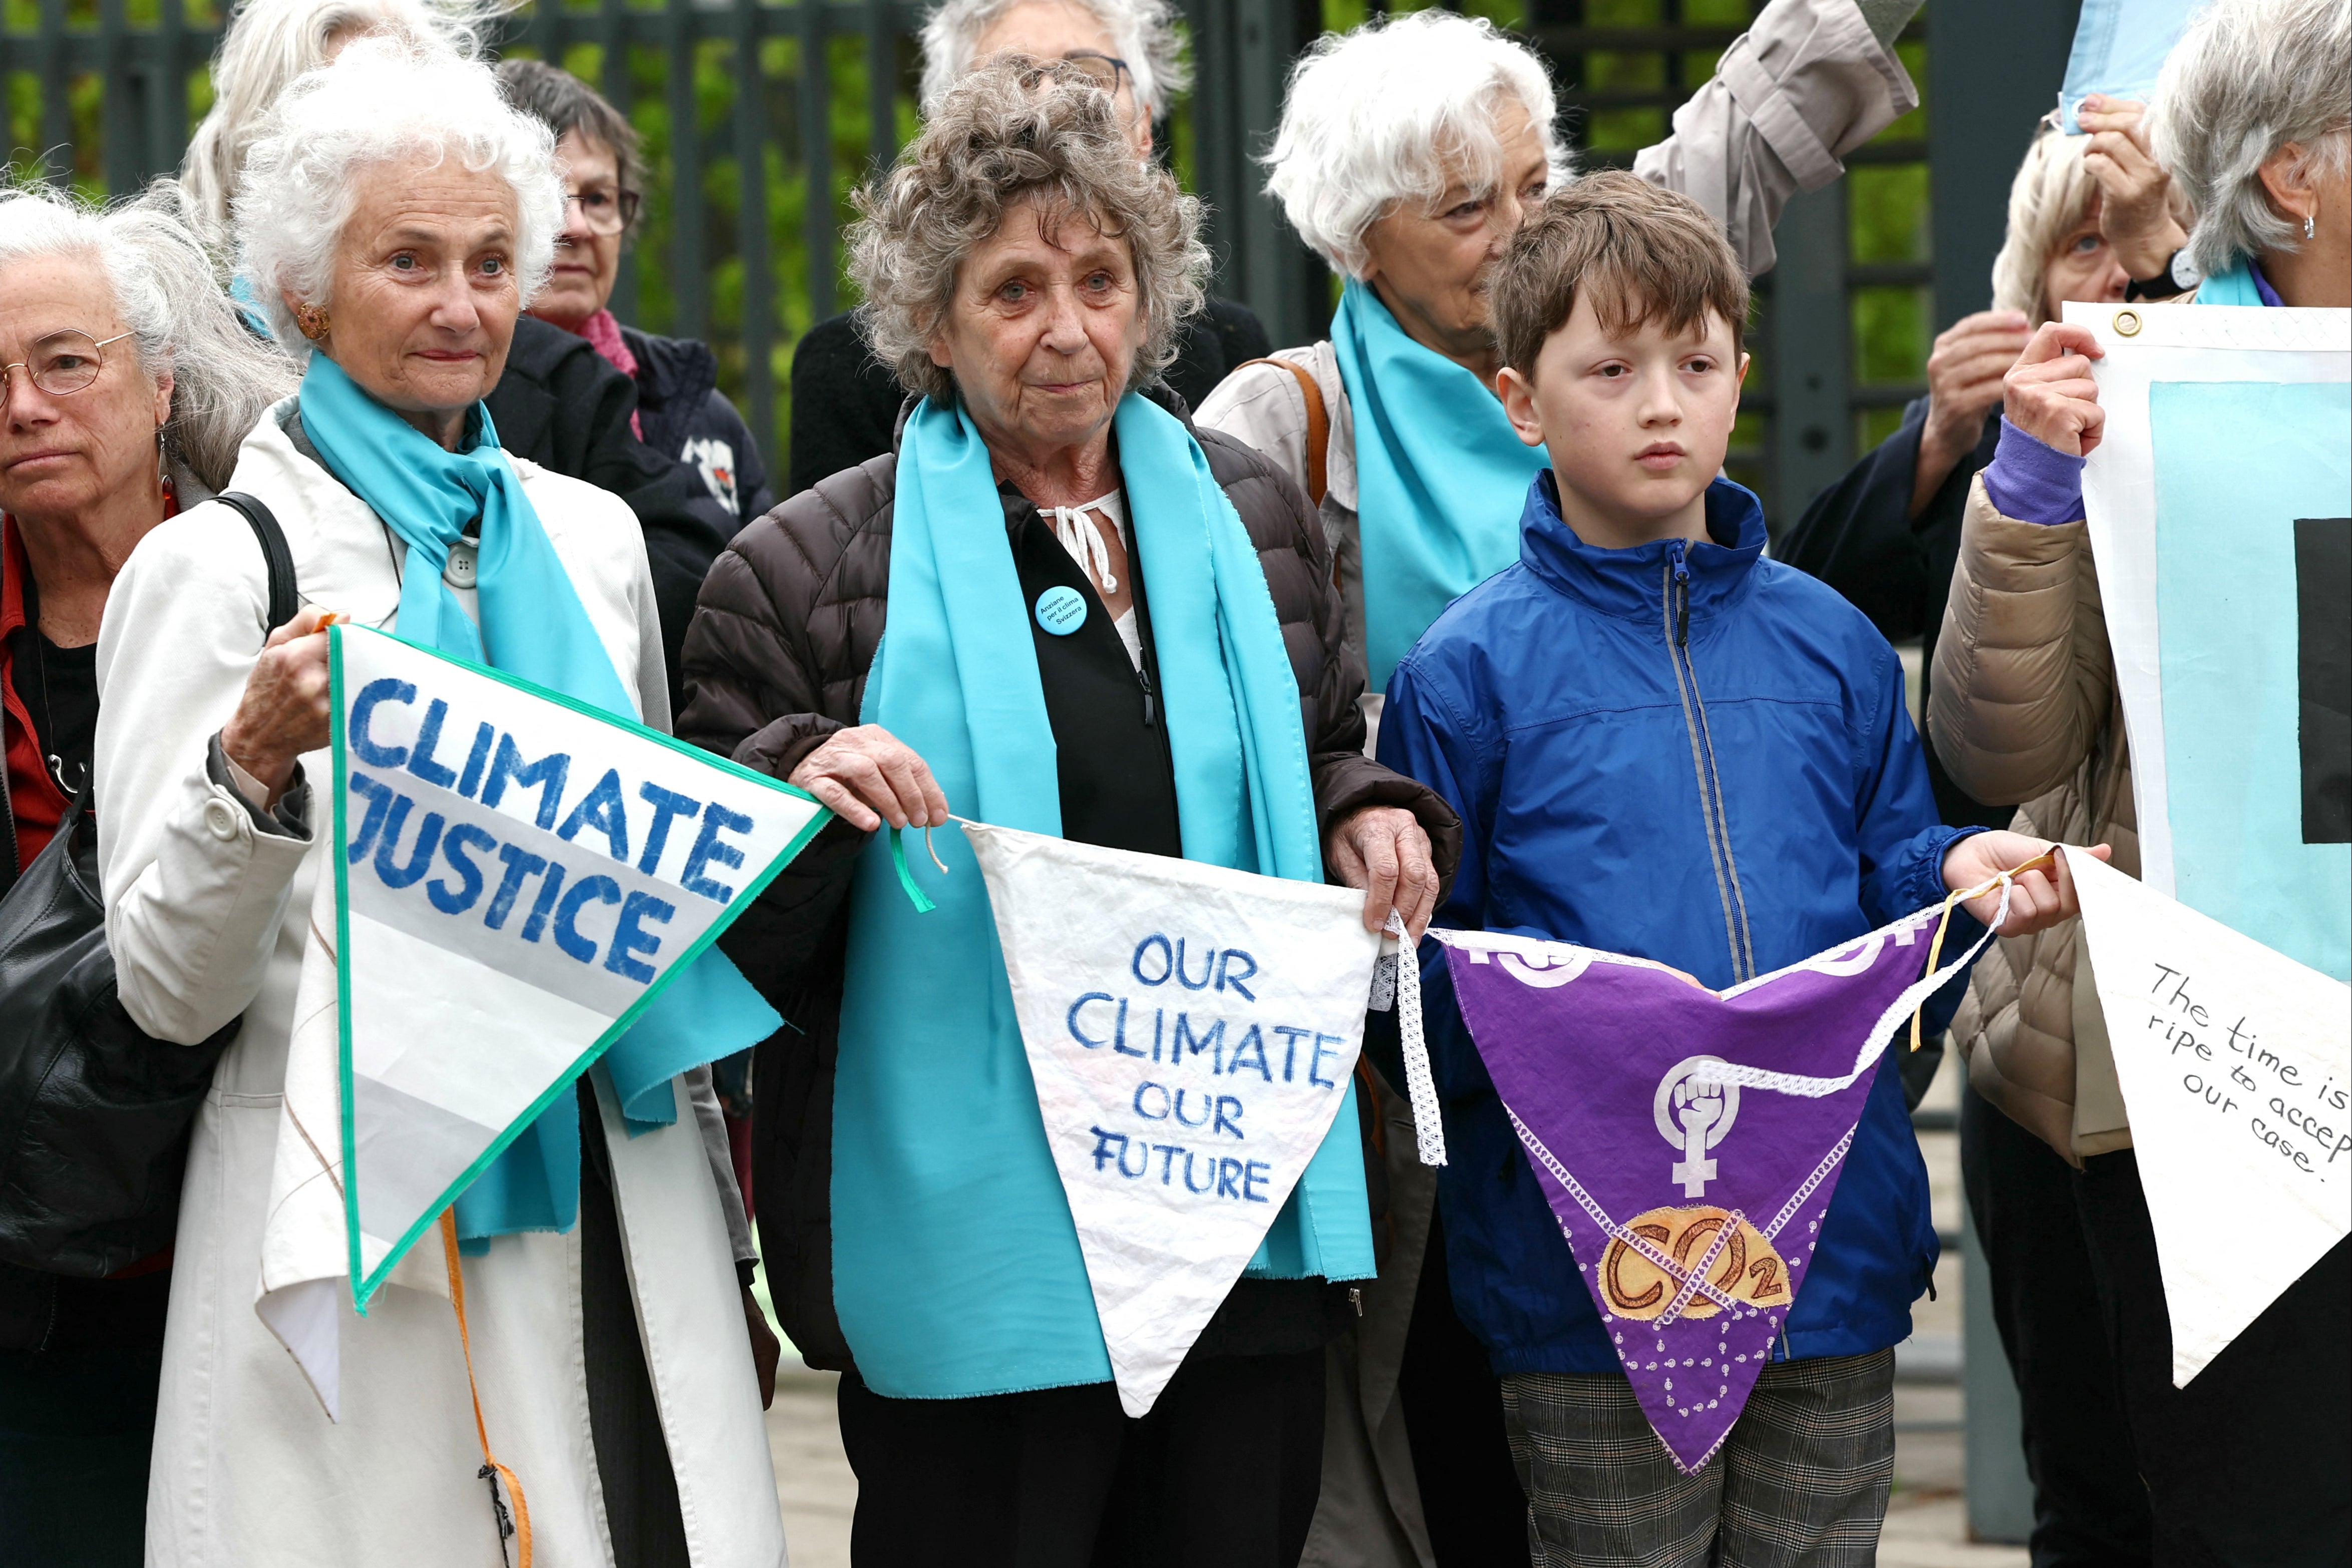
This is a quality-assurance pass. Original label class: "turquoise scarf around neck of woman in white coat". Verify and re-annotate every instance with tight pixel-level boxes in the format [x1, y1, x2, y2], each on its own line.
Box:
[301, 355, 781, 1251]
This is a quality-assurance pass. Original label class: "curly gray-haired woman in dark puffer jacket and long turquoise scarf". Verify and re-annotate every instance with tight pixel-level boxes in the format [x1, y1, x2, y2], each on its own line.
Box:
[680, 61, 1458, 1568]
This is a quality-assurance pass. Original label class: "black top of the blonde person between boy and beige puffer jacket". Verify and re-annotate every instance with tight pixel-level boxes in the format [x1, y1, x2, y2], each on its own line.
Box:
[1774, 398, 2015, 828]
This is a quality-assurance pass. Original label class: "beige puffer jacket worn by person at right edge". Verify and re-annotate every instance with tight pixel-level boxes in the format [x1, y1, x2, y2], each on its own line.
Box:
[1929, 475, 2140, 1166]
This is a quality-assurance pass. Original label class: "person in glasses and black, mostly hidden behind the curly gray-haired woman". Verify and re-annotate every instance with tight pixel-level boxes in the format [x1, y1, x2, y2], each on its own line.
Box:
[790, 0, 1272, 491]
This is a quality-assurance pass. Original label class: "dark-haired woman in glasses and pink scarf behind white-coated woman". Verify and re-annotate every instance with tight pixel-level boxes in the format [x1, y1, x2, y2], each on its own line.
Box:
[499, 59, 774, 527]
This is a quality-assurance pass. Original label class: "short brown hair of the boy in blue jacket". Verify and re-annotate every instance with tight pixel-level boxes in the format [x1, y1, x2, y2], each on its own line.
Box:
[1489, 169, 1748, 381]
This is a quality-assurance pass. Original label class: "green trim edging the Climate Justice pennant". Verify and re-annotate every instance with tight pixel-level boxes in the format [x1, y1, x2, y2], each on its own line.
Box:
[329, 625, 833, 1317]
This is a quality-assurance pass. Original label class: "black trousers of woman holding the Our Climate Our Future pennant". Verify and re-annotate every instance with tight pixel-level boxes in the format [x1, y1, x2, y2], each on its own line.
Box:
[840, 1349, 1324, 1568]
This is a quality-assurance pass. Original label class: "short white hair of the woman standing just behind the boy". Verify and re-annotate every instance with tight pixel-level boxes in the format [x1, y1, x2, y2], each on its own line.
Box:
[1265, 7, 1569, 277]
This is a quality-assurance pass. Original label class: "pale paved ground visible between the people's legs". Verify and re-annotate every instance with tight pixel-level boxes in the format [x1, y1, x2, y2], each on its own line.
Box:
[767, 1020, 2028, 1568]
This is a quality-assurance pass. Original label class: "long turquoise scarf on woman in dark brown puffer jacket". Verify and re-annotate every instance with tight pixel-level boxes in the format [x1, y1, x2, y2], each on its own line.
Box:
[833, 395, 1374, 1399]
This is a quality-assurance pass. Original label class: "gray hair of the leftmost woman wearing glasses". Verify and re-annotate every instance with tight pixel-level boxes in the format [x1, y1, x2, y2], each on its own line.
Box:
[0, 179, 294, 491]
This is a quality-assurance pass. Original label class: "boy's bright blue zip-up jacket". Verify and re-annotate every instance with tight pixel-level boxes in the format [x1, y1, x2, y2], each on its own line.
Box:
[1378, 473, 1983, 1373]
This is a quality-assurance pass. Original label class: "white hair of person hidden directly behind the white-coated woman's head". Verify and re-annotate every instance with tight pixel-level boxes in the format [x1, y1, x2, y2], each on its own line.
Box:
[179, 0, 513, 261]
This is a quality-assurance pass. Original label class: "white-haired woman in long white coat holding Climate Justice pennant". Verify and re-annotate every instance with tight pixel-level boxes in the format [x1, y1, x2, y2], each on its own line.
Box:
[97, 38, 783, 1568]
